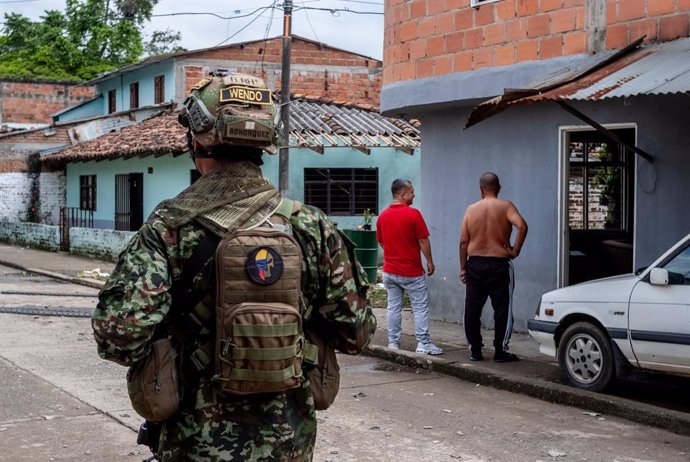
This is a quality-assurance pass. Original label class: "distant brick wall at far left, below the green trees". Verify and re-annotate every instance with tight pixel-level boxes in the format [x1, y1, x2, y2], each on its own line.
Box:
[0, 80, 94, 124]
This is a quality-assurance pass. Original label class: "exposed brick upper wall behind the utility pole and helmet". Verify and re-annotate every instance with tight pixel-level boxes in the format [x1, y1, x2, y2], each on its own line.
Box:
[184, 38, 382, 106]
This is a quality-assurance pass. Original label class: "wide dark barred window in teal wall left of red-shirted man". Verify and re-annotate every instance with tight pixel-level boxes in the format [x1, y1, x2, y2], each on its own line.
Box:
[304, 168, 379, 216]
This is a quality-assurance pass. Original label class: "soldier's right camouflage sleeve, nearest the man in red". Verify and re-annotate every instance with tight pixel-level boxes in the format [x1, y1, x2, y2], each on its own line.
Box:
[291, 206, 376, 354]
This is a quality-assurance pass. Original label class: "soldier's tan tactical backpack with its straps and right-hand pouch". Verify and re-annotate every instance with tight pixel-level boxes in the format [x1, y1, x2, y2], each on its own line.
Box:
[173, 199, 340, 410]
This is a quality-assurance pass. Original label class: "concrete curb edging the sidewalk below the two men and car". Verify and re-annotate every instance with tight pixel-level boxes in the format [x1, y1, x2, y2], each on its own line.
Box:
[364, 345, 690, 436]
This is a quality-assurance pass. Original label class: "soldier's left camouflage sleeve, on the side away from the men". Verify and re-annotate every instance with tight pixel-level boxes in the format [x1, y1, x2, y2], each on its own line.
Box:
[91, 223, 172, 366]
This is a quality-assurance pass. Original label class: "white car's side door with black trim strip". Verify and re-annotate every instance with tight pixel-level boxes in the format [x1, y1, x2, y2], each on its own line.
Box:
[629, 241, 690, 373]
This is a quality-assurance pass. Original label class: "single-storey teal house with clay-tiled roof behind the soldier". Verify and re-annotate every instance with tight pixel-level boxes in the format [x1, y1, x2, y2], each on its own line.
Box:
[43, 98, 420, 231]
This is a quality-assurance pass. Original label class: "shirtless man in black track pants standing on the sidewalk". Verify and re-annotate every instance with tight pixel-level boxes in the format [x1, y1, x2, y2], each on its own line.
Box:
[460, 172, 527, 363]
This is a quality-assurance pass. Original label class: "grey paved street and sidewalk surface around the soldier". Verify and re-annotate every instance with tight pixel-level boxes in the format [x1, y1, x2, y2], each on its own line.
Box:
[0, 248, 690, 462]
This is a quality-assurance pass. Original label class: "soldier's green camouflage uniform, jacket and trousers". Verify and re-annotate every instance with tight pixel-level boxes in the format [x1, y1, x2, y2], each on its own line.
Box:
[92, 162, 376, 461]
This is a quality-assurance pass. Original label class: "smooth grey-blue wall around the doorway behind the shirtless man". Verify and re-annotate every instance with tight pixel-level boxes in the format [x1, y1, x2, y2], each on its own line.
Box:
[415, 96, 690, 335]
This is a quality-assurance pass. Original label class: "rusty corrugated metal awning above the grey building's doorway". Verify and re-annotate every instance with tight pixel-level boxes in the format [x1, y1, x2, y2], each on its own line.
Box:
[465, 38, 690, 128]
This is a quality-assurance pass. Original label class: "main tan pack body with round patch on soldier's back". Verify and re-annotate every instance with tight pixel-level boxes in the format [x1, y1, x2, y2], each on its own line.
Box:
[214, 226, 305, 394]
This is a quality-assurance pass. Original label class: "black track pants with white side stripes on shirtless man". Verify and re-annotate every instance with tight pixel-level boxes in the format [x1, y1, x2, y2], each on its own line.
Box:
[463, 257, 515, 351]
